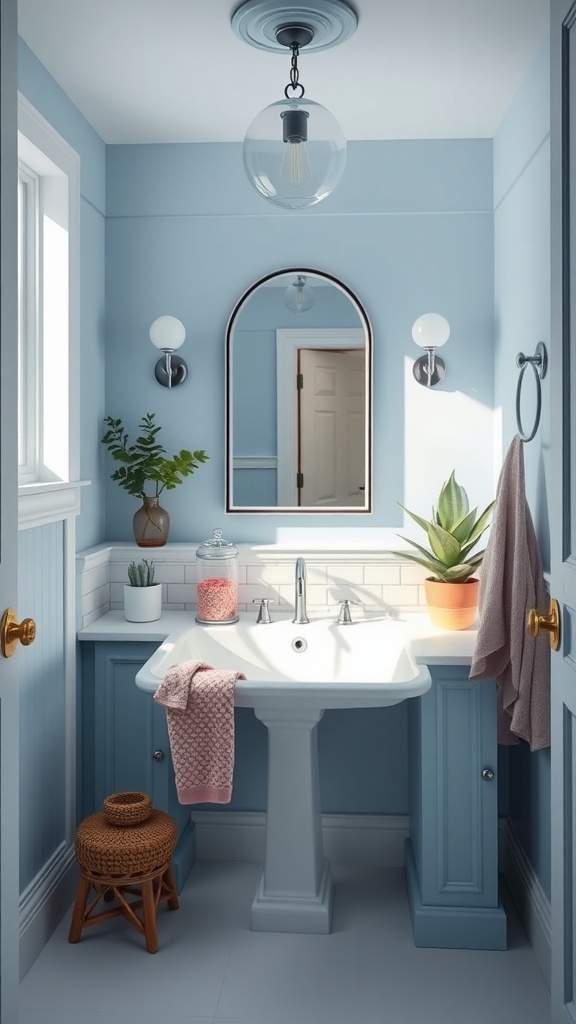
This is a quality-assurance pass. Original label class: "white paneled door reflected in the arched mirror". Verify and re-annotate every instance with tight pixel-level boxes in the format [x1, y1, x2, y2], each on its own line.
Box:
[298, 348, 366, 508]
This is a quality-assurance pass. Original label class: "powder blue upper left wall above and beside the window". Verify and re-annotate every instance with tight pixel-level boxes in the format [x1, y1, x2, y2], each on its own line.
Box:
[18, 39, 106, 550]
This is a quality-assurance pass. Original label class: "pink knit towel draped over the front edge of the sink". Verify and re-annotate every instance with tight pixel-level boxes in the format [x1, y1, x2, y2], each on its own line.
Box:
[154, 662, 246, 804]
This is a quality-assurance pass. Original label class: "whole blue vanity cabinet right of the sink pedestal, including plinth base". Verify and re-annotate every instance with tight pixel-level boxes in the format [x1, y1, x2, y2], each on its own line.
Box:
[406, 666, 506, 949]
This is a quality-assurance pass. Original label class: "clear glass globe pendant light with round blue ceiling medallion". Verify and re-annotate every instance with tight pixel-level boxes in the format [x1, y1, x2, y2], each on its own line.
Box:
[232, 0, 357, 210]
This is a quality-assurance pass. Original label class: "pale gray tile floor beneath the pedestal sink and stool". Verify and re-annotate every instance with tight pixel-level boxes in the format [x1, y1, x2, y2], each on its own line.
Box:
[20, 861, 550, 1024]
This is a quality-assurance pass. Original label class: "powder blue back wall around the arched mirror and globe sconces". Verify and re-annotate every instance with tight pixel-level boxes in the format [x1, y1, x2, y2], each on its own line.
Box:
[106, 140, 494, 542]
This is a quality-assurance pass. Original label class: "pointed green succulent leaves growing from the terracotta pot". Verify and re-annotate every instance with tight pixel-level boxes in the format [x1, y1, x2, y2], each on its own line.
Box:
[394, 470, 494, 583]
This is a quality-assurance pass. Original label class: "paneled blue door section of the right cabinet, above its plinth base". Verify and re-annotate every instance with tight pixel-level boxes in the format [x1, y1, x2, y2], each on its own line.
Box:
[410, 666, 498, 906]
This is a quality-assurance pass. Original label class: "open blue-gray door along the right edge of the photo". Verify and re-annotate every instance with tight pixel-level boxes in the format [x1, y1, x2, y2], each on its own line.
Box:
[549, 0, 576, 1024]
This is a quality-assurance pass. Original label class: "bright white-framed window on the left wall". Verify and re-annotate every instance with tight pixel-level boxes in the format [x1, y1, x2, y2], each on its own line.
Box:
[18, 96, 80, 524]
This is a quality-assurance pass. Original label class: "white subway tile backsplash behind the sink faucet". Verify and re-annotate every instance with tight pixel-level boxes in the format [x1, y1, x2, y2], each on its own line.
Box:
[77, 544, 425, 629]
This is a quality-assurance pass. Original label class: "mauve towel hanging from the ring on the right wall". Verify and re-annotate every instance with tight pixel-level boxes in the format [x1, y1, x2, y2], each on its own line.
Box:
[469, 435, 550, 751]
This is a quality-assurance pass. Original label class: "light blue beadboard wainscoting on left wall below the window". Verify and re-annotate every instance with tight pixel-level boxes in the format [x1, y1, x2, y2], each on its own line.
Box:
[18, 520, 77, 976]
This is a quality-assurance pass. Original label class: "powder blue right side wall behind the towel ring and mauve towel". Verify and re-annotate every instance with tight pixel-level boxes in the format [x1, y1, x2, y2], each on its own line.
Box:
[494, 43, 551, 896]
